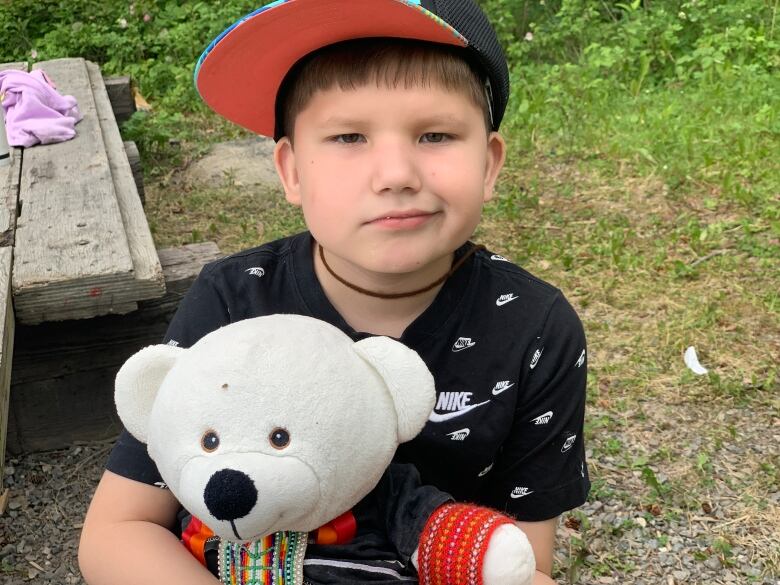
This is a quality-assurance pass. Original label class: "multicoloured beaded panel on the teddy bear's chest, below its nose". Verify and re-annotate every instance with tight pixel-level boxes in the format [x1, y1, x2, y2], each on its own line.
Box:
[219, 532, 308, 585]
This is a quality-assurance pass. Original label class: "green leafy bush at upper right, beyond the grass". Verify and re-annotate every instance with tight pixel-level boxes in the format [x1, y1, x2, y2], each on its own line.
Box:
[481, 0, 780, 84]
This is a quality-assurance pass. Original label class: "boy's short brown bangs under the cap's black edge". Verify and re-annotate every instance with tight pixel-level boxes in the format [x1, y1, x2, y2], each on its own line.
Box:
[277, 39, 492, 140]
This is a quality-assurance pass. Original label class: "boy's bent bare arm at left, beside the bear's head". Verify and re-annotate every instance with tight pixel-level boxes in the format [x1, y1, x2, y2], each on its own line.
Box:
[79, 471, 218, 585]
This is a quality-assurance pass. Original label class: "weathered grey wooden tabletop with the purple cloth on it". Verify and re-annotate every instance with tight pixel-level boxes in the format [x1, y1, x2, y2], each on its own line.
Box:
[0, 59, 174, 480]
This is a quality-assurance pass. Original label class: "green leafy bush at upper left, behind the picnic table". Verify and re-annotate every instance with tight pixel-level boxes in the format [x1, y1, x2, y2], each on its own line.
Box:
[0, 0, 256, 112]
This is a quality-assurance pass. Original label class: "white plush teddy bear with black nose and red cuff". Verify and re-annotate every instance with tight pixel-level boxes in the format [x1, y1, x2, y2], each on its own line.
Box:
[115, 315, 534, 585]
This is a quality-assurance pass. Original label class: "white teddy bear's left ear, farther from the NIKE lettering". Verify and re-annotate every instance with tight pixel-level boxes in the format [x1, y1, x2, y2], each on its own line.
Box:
[114, 345, 184, 443]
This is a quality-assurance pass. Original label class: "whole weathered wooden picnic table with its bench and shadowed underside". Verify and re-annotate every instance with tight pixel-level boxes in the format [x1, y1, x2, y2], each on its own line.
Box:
[0, 59, 201, 476]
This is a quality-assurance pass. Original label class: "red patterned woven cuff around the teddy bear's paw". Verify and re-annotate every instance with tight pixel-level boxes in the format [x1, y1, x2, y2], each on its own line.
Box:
[418, 504, 512, 585]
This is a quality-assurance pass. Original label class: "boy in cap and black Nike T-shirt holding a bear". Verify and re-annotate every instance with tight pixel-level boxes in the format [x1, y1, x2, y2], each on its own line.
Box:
[79, 0, 589, 585]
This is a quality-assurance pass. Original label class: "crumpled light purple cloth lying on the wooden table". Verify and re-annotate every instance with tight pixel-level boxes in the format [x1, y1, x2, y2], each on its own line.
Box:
[0, 69, 82, 147]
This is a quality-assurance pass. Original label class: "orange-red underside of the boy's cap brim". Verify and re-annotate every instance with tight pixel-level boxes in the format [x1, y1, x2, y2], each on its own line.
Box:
[195, 0, 467, 137]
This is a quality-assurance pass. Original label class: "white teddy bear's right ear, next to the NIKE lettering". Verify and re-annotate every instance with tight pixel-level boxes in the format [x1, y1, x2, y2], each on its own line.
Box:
[353, 337, 436, 443]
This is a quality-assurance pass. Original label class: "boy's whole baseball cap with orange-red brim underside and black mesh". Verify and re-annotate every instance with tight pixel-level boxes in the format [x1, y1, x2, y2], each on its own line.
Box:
[195, 0, 509, 140]
